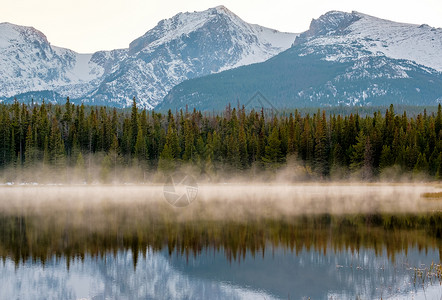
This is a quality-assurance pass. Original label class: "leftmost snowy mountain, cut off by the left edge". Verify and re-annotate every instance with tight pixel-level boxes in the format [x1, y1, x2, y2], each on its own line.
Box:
[0, 23, 108, 97]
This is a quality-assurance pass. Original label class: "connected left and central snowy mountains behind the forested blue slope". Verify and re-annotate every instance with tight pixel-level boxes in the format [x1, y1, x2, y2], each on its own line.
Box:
[0, 6, 296, 108]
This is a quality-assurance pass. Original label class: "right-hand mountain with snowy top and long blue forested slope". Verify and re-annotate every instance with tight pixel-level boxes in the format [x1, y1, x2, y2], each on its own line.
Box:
[159, 11, 442, 109]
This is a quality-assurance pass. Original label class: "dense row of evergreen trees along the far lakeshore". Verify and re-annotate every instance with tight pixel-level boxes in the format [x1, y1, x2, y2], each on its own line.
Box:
[0, 98, 442, 181]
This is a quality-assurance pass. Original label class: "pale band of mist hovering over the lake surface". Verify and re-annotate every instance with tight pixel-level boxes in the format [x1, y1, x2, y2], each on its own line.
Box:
[0, 182, 442, 220]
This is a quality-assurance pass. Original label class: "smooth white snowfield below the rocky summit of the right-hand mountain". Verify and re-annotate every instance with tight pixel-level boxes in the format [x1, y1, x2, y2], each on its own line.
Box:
[306, 12, 442, 72]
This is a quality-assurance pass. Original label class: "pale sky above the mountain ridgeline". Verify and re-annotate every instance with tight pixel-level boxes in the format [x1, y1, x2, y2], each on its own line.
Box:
[0, 0, 442, 53]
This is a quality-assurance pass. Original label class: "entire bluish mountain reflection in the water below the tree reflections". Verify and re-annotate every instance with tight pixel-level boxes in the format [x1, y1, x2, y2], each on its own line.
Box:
[0, 248, 441, 299]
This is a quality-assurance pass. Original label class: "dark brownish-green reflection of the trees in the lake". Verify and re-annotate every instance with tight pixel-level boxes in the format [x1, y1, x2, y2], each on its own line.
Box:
[0, 208, 442, 267]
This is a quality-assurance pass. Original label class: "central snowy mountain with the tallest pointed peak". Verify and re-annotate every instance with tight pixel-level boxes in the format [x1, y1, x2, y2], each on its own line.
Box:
[89, 6, 296, 108]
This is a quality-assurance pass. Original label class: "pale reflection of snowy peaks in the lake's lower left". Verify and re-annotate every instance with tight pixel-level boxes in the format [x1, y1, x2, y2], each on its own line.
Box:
[0, 251, 273, 299]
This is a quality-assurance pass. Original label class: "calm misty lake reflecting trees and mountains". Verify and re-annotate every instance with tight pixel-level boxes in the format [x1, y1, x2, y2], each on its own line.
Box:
[0, 186, 442, 299]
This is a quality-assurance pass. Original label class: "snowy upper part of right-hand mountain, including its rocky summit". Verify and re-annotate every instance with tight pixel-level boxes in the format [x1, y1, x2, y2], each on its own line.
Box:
[295, 11, 442, 71]
